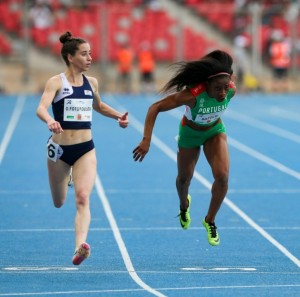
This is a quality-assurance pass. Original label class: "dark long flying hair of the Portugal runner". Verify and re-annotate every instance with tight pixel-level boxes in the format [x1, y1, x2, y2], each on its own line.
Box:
[161, 50, 233, 93]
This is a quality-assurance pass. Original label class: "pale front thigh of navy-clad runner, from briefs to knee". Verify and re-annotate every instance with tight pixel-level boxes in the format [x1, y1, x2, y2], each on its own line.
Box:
[72, 149, 97, 193]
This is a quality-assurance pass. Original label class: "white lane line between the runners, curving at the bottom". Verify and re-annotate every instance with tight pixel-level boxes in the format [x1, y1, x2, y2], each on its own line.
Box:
[95, 175, 166, 297]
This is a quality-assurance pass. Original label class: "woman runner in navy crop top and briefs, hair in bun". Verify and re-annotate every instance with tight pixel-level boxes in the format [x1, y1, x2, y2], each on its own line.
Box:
[37, 32, 128, 265]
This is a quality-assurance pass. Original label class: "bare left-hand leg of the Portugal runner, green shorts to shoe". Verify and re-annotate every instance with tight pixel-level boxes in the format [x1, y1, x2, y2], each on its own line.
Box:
[176, 147, 200, 211]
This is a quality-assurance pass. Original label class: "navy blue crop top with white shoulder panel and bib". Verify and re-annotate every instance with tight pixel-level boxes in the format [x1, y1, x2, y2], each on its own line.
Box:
[52, 73, 94, 130]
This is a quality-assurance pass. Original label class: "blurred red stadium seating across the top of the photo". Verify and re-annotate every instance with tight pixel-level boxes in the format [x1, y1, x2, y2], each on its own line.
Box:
[0, 0, 300, 92]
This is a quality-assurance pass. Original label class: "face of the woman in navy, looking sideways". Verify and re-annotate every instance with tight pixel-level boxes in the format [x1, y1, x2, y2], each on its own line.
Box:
[69, 43, 92, 71]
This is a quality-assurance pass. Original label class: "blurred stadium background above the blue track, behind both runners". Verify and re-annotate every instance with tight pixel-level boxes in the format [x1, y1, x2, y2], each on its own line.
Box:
[0, 0, 300, 94]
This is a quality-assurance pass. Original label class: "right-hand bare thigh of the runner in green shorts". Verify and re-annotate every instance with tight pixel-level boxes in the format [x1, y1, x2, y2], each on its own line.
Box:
[203, 133, 229, 173]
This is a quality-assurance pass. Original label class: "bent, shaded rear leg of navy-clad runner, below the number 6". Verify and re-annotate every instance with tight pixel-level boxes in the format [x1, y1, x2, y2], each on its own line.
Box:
[47, 159, 71, 207]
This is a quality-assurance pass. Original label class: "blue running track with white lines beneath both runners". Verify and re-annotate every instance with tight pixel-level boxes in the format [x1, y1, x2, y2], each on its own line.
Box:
[0, 94, 300, 297]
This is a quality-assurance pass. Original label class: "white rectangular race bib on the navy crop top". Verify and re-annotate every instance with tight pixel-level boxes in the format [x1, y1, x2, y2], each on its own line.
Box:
[64, 99, 93, 122]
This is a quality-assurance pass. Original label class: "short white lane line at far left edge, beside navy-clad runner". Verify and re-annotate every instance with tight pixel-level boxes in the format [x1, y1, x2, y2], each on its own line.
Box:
[0, 95, 26, 165]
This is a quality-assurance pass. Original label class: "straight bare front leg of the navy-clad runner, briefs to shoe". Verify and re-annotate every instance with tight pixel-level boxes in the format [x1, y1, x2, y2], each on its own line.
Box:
[72, 149, 97, 248]
